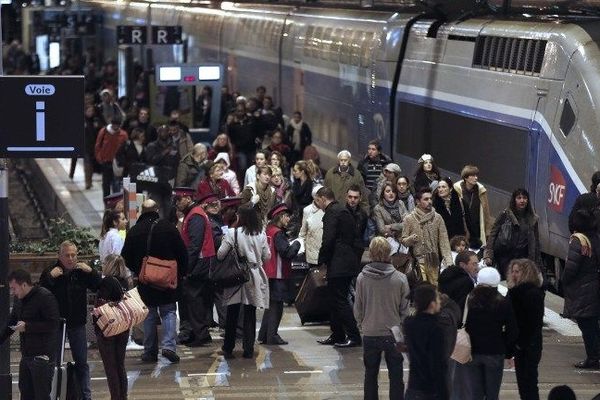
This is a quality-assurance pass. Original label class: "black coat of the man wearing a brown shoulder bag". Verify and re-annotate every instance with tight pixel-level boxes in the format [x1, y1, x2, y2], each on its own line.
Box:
[121, 211, 188, 307]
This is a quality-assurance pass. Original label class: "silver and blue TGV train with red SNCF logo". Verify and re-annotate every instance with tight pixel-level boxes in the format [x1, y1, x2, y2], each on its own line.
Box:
[85, 0, 600, 276]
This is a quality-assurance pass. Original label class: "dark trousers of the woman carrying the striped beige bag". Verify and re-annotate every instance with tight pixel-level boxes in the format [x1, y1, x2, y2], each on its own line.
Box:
[96, 330, 129, 400]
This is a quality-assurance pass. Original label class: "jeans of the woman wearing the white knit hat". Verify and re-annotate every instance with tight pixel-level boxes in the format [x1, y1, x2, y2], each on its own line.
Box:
[465, 354, 504, 400]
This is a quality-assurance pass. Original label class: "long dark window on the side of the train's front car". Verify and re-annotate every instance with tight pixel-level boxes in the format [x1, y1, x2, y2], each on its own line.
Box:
[395, 102, 528, 193]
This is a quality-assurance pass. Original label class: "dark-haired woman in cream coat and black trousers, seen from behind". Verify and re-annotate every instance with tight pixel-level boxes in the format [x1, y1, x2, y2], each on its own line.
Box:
[217, 204, 271, 359]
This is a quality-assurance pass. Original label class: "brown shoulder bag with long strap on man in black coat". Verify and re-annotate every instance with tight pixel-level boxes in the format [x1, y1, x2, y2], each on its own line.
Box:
[139, 220, 177, 290]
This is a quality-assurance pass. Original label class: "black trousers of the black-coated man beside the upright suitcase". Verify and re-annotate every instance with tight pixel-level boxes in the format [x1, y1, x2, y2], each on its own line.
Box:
[327, 276, 361, 343]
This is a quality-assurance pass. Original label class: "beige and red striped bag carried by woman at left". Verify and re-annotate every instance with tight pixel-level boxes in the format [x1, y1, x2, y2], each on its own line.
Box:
[92, 287, 148, 337]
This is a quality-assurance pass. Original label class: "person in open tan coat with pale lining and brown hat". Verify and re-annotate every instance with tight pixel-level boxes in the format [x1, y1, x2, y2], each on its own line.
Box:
[454, 165, 494, 248]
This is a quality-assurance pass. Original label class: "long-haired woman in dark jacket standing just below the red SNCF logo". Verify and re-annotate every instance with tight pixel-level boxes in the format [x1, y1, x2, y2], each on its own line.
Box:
[483, 189, 542, 279]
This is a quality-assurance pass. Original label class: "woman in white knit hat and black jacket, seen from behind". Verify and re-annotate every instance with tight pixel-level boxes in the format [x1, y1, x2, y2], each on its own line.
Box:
[462, 267, 518, 400]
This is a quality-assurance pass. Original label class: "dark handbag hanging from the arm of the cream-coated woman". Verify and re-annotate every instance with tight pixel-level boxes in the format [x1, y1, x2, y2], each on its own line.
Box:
[208, 228, 250, 288]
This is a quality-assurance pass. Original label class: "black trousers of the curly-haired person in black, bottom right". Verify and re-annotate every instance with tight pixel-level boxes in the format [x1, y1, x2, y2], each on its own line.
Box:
[515, 335, 542, 400]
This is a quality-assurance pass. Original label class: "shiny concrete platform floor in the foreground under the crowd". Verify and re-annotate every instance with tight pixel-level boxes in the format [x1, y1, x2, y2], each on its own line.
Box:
[11, 307, 600, 400]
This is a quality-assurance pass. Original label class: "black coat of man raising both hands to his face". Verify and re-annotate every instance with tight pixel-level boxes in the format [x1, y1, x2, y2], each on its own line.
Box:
[40, 261, 102, 328]
